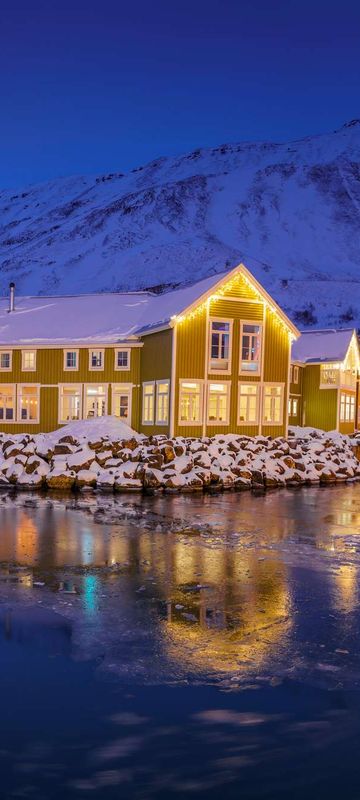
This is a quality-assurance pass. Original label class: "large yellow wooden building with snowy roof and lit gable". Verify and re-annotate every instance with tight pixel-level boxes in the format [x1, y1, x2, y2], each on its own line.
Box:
[0, 264, 299, 437]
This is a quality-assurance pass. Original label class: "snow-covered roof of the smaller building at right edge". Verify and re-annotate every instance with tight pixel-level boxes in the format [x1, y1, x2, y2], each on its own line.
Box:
[291, 328, 354, 364]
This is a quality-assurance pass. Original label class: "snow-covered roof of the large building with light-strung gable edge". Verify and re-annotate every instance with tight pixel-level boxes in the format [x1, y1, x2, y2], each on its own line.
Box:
[0, 264, 299, 347]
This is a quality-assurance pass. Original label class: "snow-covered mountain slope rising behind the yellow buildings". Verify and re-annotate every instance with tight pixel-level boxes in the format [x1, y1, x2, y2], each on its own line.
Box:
[0, 120, 360, 327]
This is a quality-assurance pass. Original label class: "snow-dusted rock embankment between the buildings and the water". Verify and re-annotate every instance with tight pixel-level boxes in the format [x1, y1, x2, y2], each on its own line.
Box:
[0, 417, 360, 493]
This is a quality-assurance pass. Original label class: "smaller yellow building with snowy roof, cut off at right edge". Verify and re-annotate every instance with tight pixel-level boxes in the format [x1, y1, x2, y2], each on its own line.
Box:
[289, 328, 360, 433]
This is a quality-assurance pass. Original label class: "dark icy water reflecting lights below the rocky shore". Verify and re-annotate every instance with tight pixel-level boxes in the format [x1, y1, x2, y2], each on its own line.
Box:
[0, 484, 360, 800]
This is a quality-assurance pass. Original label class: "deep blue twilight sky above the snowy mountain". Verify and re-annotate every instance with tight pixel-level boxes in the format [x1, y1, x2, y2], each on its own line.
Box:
[0, 0, 360, 187]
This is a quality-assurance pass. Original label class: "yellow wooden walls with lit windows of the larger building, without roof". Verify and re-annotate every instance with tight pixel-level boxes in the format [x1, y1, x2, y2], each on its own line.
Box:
[0, 266, 297, 437]
